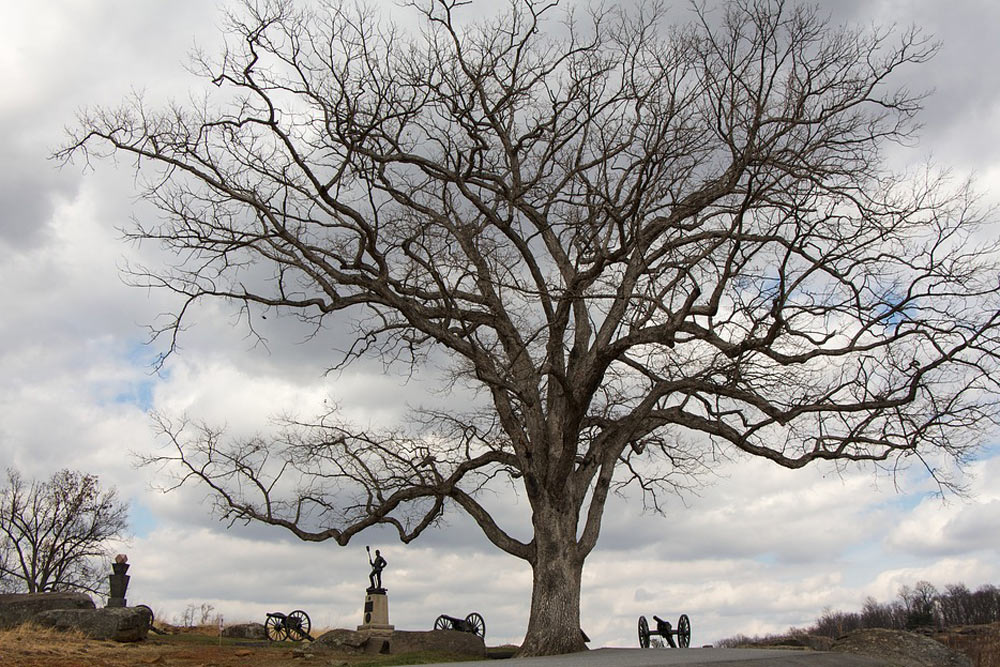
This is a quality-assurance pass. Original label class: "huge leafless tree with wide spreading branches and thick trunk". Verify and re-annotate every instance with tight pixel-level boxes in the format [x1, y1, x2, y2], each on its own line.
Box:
[61, 0, 1000, 654]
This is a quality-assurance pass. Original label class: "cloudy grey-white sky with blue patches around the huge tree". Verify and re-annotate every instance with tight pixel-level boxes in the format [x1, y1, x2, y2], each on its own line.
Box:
[0, 0, 1000, 646]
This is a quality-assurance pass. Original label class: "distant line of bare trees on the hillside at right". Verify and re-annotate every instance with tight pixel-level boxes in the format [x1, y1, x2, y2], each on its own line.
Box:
[715, 581, 1000, 647]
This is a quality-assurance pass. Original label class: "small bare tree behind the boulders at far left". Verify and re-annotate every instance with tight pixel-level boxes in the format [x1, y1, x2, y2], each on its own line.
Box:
[0, 469, 128, 593]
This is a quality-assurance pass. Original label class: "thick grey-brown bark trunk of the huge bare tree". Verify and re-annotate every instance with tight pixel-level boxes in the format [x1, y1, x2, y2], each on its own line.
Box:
[518, 509, 587, 656]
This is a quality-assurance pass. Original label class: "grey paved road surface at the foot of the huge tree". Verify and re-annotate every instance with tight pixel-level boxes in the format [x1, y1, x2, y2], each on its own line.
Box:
[402, 648, 887, 667]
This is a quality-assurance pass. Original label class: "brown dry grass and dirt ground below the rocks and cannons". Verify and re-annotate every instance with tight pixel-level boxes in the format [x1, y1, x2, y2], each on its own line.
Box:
[0, 626, 476, 667]
